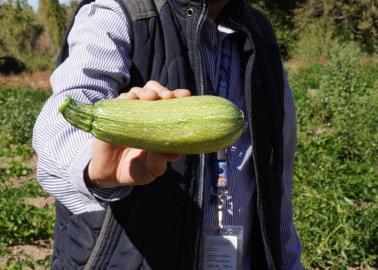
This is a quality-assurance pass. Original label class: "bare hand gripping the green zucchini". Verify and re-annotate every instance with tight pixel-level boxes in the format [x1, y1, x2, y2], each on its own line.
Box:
[85, 81, 190, 188]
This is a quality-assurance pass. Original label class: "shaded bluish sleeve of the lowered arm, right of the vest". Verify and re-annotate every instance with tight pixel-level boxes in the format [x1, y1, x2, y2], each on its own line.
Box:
[281, 74, 304, 270]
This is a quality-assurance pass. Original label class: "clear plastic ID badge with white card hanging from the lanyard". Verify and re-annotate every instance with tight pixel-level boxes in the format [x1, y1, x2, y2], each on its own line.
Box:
[203, 226, 243, 270]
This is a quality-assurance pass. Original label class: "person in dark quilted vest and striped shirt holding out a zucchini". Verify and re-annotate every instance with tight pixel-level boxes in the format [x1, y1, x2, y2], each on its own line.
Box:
[33, 0, 303, 270]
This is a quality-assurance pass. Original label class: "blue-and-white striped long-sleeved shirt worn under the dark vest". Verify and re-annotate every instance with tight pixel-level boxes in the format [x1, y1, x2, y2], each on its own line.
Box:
[33, 0, 301, 270]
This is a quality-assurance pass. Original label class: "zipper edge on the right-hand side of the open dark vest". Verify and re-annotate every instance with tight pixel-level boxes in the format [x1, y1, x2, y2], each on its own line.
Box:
[232, 21, 276, 270]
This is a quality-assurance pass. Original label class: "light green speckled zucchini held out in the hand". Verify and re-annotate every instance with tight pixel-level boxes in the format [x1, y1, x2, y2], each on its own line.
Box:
[59, 96, 244, 154]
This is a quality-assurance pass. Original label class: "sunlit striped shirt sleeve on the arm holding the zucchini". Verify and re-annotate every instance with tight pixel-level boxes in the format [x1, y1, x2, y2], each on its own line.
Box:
[33, 0, 132, 214]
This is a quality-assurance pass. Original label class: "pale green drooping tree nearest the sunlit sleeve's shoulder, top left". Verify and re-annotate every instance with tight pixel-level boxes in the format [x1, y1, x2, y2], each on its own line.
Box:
[38, 0, 66, 51]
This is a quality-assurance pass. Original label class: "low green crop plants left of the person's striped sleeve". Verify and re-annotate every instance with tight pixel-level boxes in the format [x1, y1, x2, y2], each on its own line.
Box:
[0, 85, 54, 269]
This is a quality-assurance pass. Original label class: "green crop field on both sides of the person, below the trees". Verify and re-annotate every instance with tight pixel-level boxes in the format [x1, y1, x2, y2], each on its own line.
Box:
[0, 53, 378, 269]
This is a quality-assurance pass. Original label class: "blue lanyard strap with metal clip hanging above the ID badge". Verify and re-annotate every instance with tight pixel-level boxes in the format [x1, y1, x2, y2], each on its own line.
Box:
[214, 35, 232, 229]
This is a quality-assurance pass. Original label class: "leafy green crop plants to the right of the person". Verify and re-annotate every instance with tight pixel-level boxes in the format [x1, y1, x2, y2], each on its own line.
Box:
[290, 46, 378, 269]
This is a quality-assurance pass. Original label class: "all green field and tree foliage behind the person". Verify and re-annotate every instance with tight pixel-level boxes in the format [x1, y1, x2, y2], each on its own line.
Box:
[0, 0, 378, 269]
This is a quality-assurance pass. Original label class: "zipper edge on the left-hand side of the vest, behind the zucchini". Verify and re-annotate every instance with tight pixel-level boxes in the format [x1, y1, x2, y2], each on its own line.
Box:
[194, 2, 208, 269]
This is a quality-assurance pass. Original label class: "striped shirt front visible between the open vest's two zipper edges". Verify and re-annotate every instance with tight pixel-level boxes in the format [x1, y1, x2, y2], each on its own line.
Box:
[199, 21, 255, 270]
